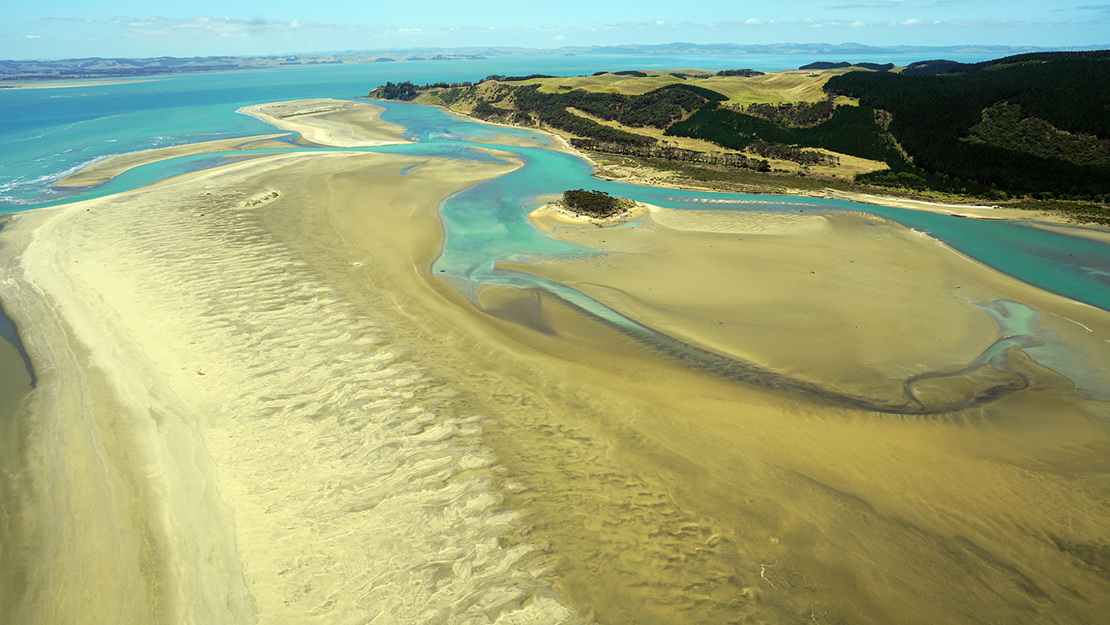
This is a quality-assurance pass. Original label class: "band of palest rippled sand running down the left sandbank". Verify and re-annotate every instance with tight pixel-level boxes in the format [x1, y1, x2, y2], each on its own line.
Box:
[32, 164, 578, 624]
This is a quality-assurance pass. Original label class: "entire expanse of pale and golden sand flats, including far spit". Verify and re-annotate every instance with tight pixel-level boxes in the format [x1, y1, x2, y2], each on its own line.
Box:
[0, 101, 1110, 625]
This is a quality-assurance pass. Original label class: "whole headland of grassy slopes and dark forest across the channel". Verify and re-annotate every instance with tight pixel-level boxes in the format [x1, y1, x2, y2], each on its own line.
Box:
[371, 51, 1110, 204]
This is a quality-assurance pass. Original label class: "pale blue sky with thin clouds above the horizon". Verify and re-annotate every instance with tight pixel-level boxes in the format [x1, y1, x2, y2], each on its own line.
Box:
[0, 0, 1110, 59]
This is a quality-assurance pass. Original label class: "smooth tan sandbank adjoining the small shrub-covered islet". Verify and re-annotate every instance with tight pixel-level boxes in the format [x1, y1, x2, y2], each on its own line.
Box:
[504, 206, 1110, 410]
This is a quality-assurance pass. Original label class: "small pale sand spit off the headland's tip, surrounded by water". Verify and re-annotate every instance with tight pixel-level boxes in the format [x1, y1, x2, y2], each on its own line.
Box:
[239, 98, 404, 148]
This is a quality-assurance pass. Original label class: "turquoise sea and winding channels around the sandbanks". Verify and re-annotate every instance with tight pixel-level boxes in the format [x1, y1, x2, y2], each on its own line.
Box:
[0, 57, 1110, 401]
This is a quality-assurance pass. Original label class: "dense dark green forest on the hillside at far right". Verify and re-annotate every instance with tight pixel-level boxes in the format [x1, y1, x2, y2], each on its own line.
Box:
[826, 52, 1110, 199]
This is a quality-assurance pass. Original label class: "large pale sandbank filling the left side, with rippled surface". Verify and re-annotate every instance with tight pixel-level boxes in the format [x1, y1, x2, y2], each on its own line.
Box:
[2, 153, 590, 623]
